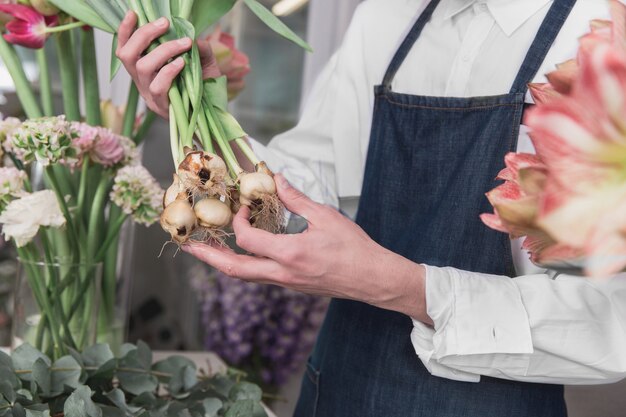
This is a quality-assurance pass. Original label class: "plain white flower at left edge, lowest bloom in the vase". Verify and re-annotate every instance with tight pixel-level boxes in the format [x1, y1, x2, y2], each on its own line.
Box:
[0, 190, 65, 248]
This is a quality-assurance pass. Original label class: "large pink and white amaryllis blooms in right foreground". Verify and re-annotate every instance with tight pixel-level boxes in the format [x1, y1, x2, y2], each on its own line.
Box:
[482, 0, 626, 276]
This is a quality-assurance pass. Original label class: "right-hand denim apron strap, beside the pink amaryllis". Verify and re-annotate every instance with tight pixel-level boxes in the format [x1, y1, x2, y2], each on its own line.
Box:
[511, 0, 576, 94]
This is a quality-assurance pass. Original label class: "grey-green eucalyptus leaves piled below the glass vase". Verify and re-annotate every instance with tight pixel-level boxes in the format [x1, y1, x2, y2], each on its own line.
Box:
[0, 342, 267, 417]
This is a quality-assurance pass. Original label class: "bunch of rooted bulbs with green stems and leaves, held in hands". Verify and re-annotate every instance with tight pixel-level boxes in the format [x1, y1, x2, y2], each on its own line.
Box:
[44, 0, 310, 244]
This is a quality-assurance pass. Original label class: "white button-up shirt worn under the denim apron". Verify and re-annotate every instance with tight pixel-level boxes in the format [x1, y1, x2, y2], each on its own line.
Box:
[247, 0, 626, 384]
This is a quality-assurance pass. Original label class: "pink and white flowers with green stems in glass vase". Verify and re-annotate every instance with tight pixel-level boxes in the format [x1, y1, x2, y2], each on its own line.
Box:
[0, 116, 163, 357]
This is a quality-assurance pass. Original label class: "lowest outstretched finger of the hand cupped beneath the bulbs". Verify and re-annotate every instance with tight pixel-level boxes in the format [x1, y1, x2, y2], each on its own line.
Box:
[183, 239, 282, 283]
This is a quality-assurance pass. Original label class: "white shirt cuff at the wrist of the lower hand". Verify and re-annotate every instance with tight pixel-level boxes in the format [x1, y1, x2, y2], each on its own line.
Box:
[426, 266, 533, 358]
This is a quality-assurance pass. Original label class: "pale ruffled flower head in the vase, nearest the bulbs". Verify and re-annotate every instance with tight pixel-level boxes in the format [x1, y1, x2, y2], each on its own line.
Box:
[111, 165, 164, 226]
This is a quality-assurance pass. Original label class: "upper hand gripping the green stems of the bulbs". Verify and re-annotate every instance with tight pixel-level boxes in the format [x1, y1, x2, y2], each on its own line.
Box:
[116, 11, 221, 119]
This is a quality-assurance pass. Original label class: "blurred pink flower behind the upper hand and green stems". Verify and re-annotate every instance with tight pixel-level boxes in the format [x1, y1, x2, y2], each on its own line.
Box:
[208, 27, 250, 100]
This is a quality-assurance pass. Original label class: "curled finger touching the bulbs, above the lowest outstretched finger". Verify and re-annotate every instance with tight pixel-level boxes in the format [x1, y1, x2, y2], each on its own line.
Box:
[233, 206, 292, 262]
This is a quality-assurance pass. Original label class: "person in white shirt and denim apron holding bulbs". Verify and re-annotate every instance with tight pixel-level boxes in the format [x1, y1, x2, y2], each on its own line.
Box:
[118, 0, 626, 417]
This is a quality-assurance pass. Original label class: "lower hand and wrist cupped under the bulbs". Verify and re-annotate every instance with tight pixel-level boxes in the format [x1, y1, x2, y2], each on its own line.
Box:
[183, 175, 431, 324]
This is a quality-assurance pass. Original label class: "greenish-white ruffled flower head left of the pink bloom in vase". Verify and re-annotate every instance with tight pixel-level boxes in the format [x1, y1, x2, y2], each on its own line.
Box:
[9, 116, 76, 166]
